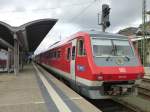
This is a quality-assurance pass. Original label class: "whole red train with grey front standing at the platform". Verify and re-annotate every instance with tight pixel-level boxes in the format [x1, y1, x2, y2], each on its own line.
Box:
[36, 31, 144, 99]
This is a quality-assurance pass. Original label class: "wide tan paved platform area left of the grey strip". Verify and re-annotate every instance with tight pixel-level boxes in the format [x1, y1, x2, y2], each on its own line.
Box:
[0, 65, 47, 112]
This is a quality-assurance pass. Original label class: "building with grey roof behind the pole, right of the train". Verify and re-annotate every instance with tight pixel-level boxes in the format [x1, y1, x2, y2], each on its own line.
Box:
[118, 22, 150, 66]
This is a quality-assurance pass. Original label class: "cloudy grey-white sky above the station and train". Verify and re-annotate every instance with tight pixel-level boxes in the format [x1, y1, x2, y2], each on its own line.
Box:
[0, 0, 150, 52]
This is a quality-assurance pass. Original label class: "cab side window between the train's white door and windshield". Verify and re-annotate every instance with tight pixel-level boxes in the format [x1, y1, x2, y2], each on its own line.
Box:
[78, 40, 86, 56]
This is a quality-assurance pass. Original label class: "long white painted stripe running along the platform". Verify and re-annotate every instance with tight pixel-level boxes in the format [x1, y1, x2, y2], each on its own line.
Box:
[33, 64, 71, 112]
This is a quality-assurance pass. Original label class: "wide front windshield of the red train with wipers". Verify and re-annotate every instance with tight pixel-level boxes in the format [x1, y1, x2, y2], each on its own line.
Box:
[92, 37, 135, 57]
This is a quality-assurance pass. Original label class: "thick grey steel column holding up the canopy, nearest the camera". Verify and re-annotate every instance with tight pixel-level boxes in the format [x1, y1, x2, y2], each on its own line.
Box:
[13, 33, 19, 75]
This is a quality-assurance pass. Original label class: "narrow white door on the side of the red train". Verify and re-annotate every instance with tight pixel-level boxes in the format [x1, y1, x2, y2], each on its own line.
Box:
[70, 39, 77, 82]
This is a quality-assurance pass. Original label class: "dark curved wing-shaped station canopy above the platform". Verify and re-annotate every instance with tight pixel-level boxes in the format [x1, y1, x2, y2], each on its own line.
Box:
[0, 19, 57, 52]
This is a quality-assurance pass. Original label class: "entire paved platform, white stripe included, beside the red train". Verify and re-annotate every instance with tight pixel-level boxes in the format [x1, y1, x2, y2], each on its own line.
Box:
[0, 64, 101, 112]
